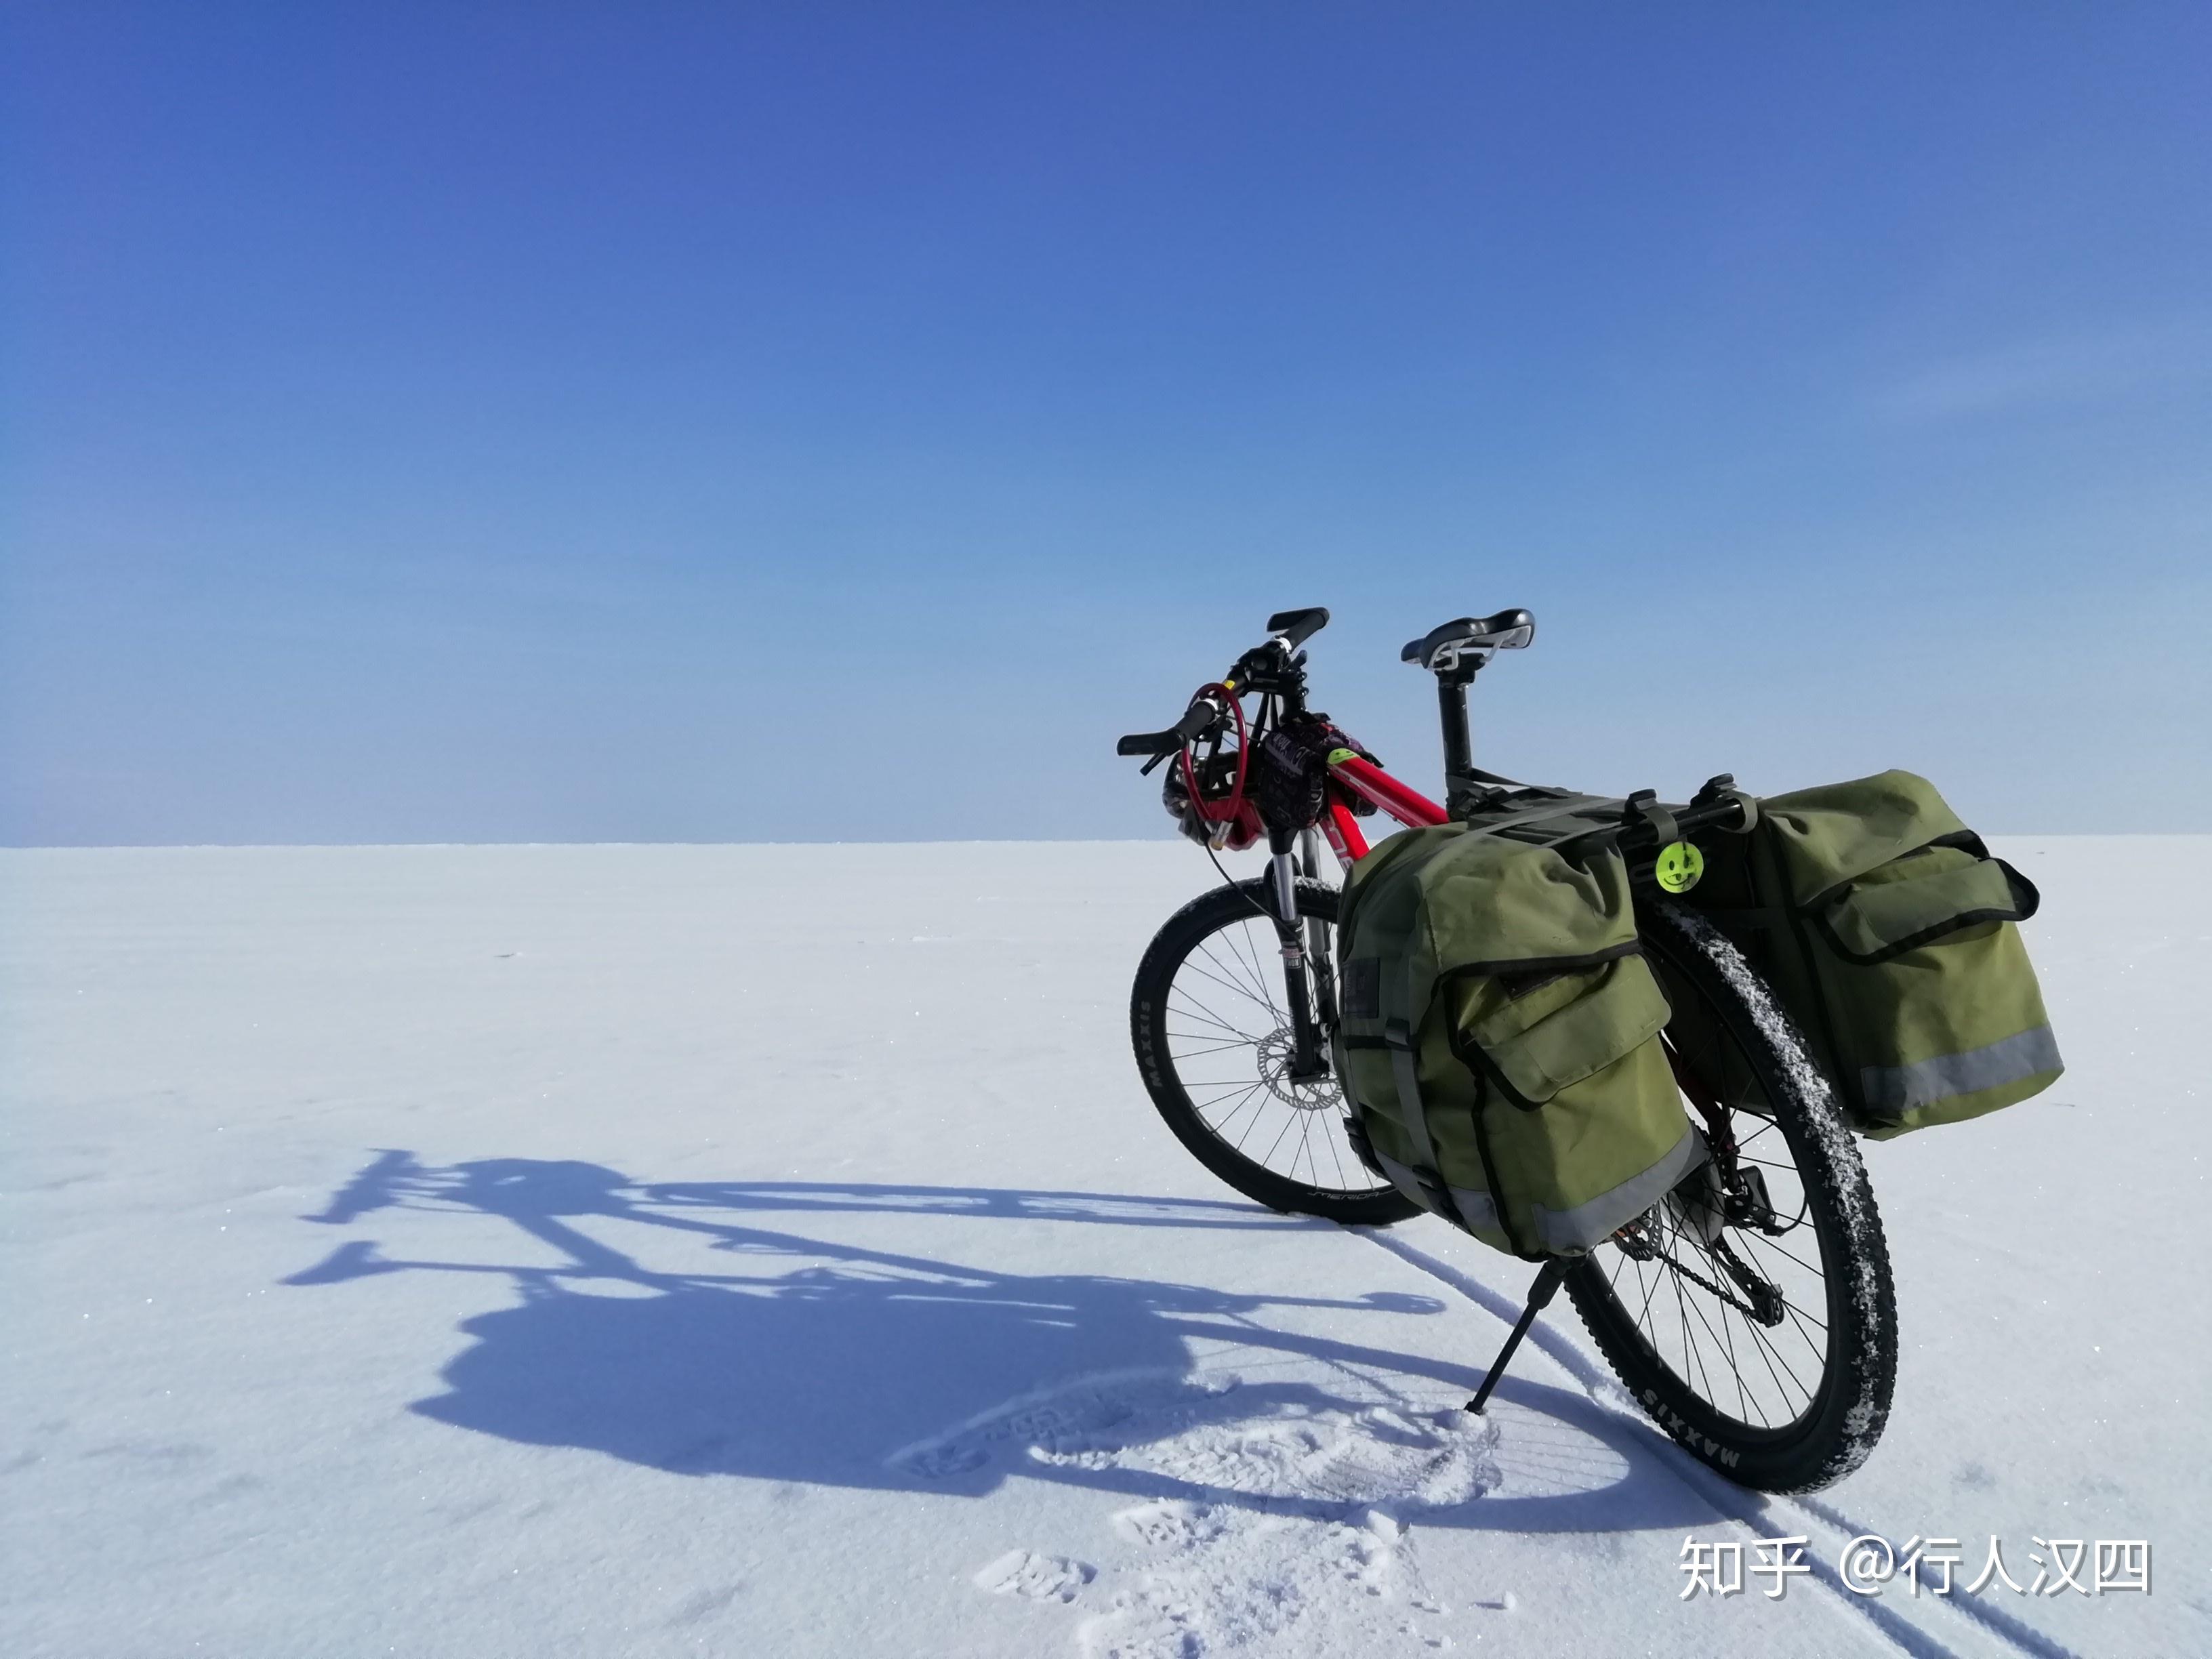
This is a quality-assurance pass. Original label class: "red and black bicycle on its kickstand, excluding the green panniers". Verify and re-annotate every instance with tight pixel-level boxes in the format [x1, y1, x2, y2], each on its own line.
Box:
[1117, 609, 1898, 1491]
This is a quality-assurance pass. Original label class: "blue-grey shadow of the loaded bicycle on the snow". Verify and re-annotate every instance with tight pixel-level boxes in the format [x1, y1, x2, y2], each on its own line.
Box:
[283, 1150, 1712, 1531]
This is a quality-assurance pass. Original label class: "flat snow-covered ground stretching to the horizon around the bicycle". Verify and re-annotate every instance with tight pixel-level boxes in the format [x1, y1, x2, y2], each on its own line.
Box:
[0, 838, 2212, 1659]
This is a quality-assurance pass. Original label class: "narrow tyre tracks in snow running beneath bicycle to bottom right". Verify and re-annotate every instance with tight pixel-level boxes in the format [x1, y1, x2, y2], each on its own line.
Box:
[1347, 1228, 2079, 1659]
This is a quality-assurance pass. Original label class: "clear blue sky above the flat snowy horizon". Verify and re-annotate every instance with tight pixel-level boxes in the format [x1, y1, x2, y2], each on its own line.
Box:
[0, 0, 2212, 845]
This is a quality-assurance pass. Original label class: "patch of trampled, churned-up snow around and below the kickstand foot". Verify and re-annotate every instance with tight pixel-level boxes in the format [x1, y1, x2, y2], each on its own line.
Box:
[928, 1374, 1509, 1659]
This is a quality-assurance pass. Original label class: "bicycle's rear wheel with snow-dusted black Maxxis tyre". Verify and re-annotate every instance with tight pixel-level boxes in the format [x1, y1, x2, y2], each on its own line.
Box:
[1566, 905, 1898, 1491]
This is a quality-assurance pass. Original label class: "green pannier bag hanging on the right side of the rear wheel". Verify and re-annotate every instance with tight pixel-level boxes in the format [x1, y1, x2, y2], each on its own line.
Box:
[1687, 772, 2062, 1139]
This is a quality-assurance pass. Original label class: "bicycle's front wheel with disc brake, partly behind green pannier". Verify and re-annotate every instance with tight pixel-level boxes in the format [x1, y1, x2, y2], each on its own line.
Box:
[1128, 880, 1420, 1228]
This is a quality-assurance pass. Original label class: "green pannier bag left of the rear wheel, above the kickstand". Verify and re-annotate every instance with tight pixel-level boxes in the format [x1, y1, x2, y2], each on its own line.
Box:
[1334, 805, 1706, 1261]
